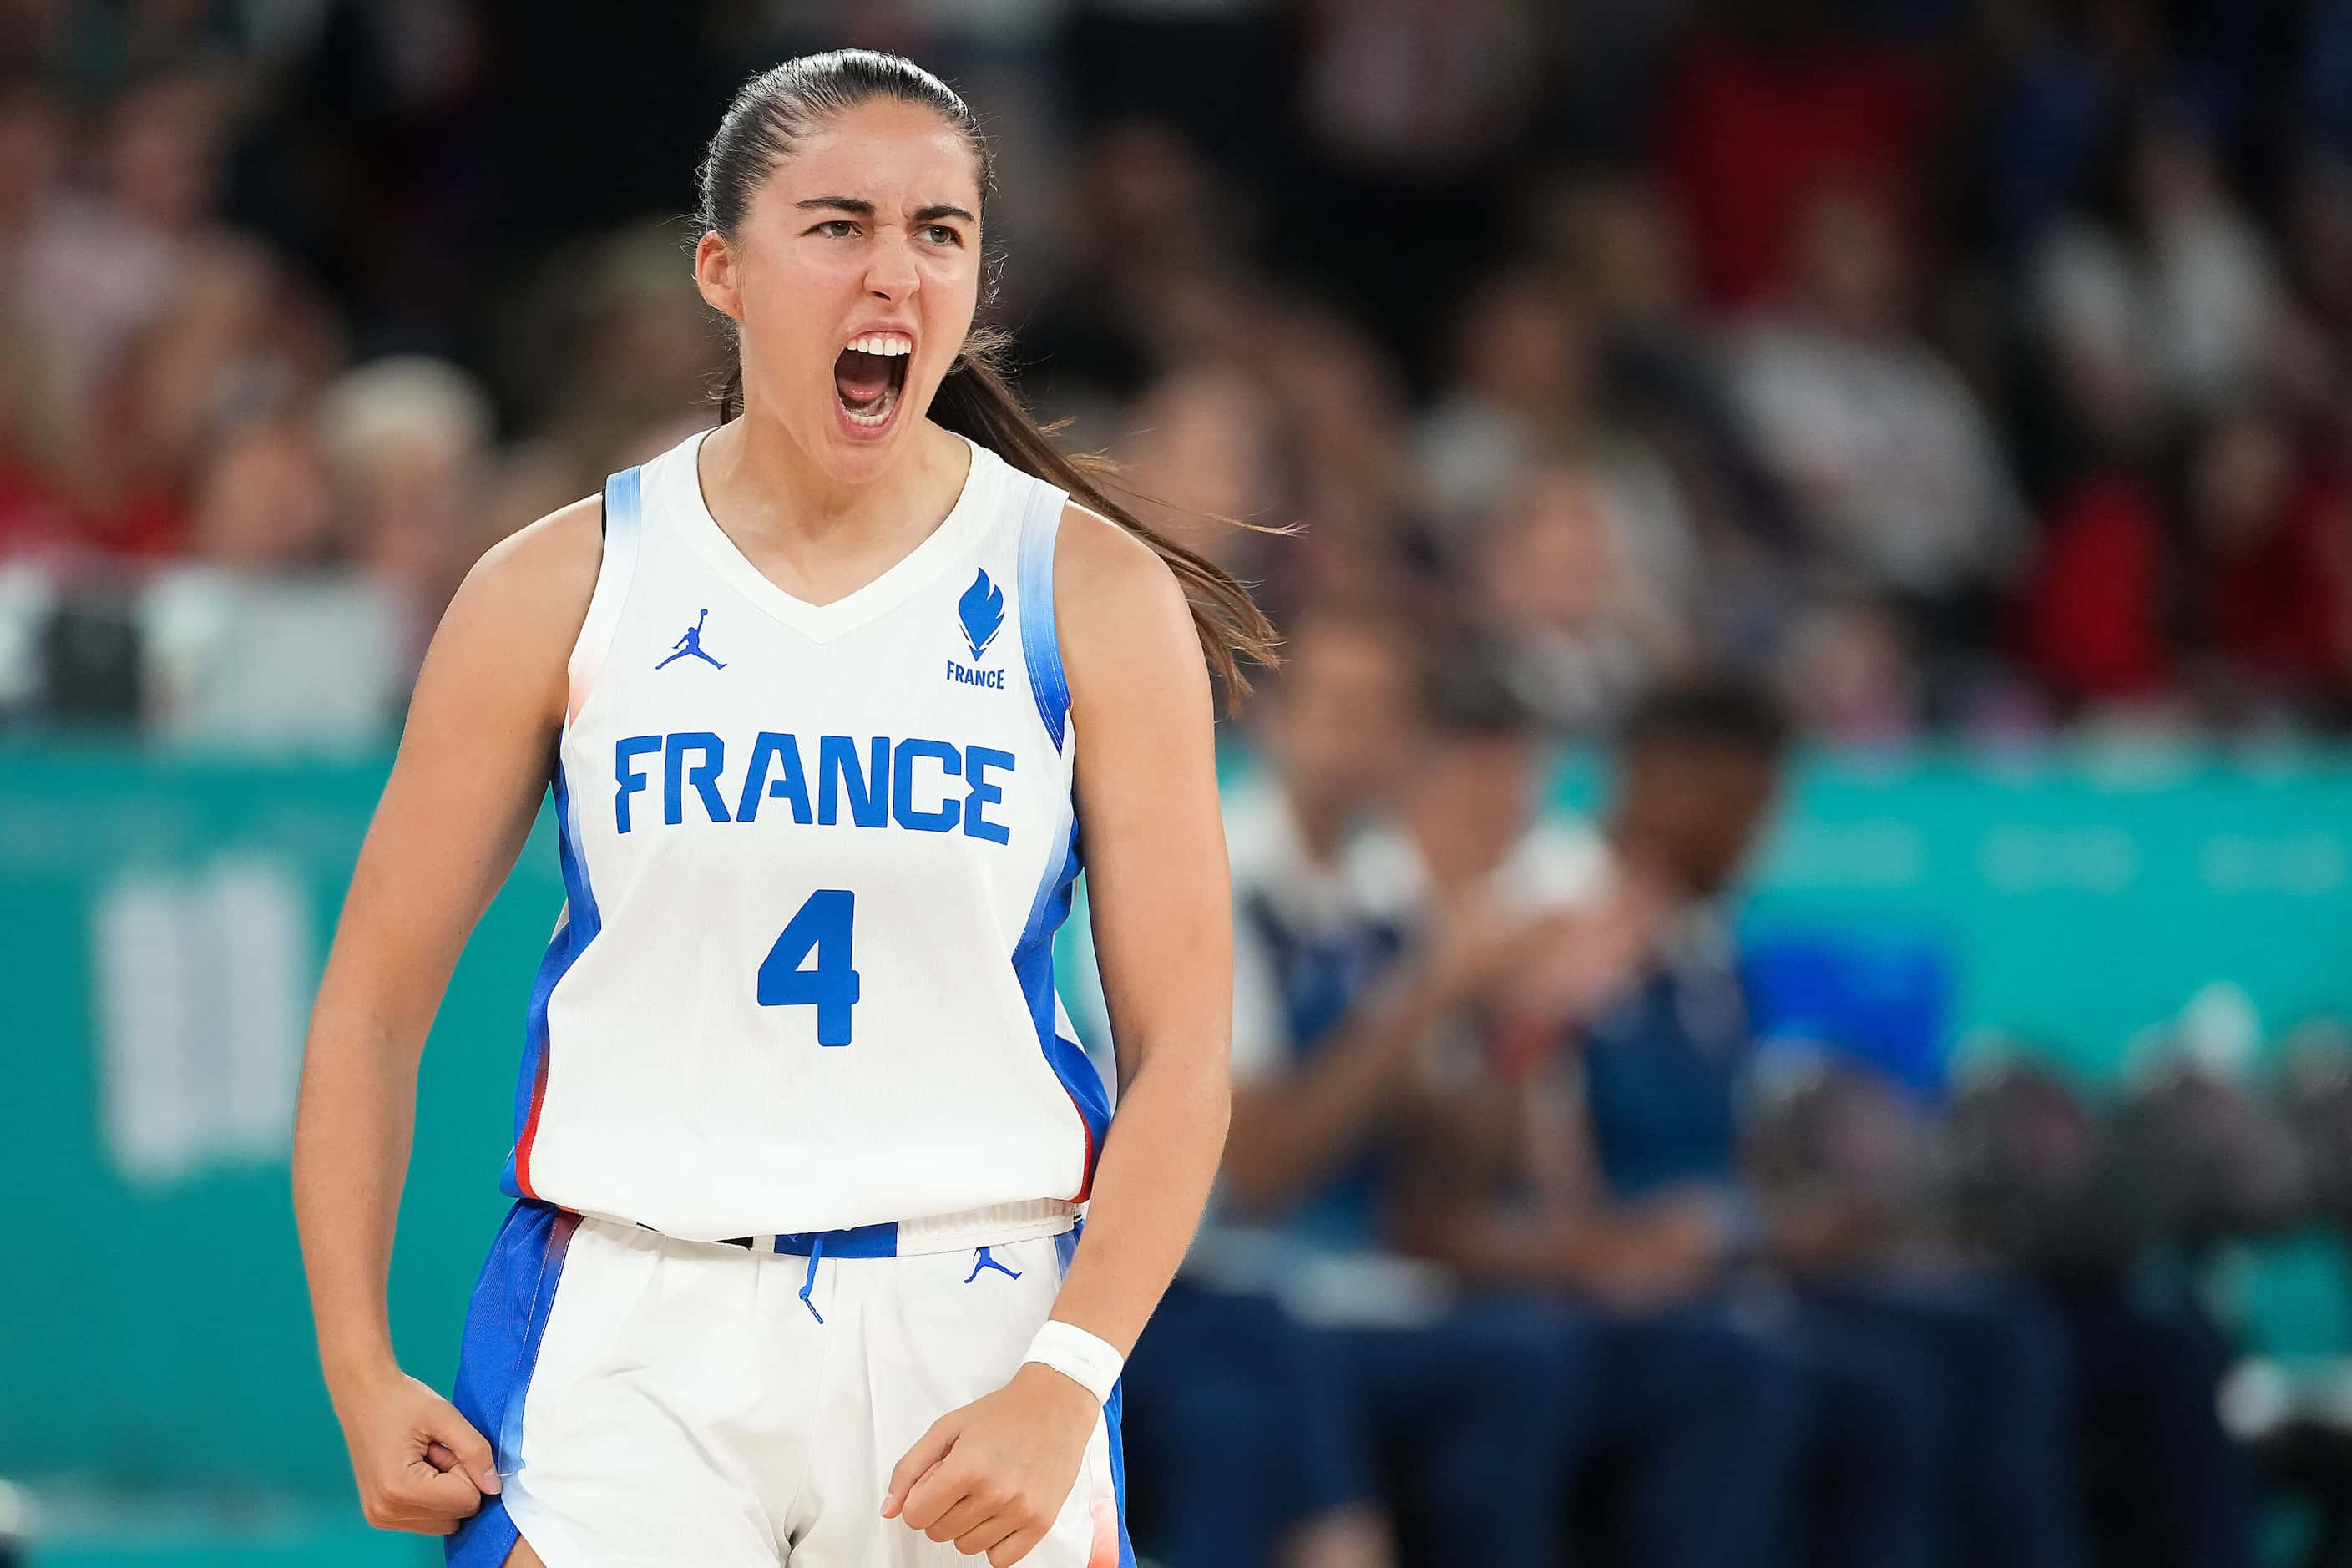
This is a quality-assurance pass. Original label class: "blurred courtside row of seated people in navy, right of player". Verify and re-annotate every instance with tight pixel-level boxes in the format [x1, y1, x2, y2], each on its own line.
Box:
[1125, 630, 2352, 1568]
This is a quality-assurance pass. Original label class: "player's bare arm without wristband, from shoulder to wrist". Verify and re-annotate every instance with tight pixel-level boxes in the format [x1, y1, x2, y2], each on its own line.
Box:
[294, 501, 599, 1524]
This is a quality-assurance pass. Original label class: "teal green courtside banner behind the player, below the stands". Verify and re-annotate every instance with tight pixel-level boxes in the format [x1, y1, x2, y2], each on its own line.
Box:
[0, 746, 2352, 1523]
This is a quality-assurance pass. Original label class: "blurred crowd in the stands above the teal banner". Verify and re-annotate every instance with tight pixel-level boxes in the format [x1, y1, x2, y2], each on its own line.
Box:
[0, 0, 2352, 746]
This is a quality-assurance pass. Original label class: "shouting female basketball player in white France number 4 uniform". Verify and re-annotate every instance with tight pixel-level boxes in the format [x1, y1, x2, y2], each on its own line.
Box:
[294, 52, 1270, 1568]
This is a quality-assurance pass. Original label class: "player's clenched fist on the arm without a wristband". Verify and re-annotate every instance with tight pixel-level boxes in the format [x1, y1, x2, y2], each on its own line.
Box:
[336, 1370, 498, 1535]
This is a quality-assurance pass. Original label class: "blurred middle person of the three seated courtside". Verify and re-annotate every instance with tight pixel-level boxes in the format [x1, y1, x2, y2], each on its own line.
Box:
[1385, 649, 1802, 1568]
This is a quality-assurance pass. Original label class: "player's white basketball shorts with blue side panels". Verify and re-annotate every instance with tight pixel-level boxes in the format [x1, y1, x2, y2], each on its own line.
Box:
[447, 1201, 1134, 1568]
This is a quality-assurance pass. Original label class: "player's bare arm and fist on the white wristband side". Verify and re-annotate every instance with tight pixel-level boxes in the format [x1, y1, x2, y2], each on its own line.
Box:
[882, 508, 1232, 1568]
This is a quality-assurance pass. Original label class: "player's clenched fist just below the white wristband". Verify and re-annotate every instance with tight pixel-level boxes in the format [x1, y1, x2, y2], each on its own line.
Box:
[882, 1361, 1103, 1568]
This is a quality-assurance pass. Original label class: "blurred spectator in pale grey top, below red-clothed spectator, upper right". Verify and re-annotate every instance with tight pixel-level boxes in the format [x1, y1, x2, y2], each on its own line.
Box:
[1731, 185, 2021, 611]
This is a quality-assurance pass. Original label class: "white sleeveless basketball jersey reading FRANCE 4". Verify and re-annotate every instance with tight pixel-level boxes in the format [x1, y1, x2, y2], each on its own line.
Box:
[506, 435, 1108, 1239]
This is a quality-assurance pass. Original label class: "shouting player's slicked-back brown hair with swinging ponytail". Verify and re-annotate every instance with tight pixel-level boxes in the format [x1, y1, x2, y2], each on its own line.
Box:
[696, 49, 1279, 706]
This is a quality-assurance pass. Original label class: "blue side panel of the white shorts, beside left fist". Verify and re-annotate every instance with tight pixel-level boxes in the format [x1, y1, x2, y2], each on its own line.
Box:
[447, 1201, 581, 1568]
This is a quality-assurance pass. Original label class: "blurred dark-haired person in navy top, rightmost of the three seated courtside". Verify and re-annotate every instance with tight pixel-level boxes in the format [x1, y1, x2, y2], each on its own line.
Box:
[1383, 682, 2079, 1568]
